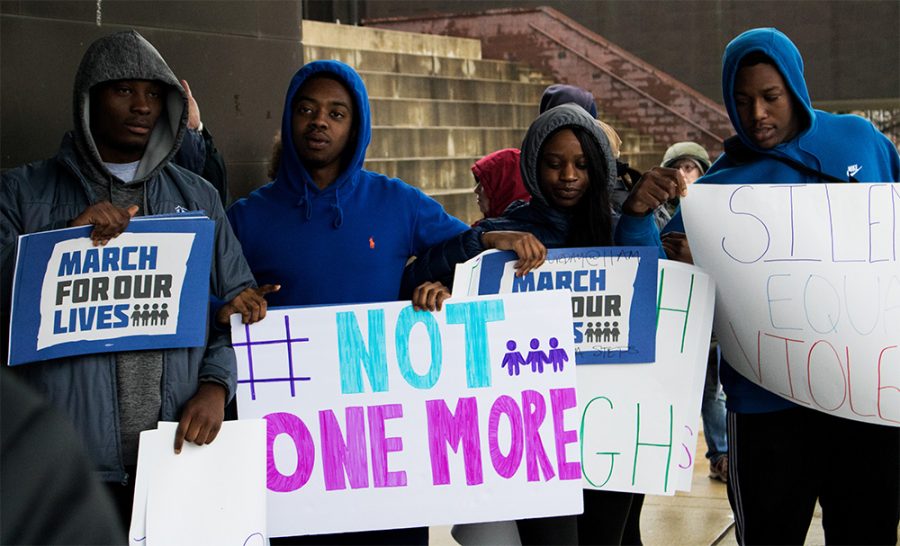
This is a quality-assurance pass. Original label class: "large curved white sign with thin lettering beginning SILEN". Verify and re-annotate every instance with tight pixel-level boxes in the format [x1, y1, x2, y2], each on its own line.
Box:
[683, 183, 900, 426]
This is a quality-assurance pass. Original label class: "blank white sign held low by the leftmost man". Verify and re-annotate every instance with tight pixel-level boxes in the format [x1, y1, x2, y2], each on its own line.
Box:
[128, 419, 268, 546]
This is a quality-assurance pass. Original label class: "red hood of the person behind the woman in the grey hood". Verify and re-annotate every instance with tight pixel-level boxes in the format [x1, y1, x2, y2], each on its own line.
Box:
[472, 148, 531, 218]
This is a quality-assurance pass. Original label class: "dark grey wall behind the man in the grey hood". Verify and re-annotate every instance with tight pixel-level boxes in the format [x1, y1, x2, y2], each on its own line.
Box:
[0, 0, 303, 197]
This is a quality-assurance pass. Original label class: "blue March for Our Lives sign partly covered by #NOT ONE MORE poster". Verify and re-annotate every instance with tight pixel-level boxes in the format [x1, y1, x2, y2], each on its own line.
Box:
[453, 247, 658, 364]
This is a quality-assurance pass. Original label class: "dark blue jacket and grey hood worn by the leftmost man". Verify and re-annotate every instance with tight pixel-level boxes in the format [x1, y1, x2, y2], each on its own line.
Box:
[0, 29, 253, 481]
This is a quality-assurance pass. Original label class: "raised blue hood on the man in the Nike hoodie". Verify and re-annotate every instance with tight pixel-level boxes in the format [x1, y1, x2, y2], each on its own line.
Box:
[722, 28, 816, 152]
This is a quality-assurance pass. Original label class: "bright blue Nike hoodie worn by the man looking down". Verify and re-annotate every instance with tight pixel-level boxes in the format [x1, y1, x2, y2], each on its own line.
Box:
[616, 28, 900, 413]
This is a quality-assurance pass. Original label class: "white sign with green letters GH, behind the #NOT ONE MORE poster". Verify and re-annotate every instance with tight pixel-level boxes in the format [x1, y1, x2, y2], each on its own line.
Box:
[458, 255, 715, 495]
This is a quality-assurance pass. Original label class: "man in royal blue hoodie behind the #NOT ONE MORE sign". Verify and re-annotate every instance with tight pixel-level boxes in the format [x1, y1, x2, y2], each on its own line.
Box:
[228, 57, 468, 544]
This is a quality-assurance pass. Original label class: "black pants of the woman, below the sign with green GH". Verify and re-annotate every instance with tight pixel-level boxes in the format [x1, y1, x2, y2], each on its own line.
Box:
[516, 489, 644, 546]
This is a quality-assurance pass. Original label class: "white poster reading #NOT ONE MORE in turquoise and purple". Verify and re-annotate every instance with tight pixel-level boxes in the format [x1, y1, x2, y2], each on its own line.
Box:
[232, 291, 582, 536]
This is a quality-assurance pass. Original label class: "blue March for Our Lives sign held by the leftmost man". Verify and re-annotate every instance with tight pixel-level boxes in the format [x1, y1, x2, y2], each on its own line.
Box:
[9, 213, 214, 366]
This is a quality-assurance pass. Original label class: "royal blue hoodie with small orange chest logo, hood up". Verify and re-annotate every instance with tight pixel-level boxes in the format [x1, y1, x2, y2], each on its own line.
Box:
[228, 61, 468, 306]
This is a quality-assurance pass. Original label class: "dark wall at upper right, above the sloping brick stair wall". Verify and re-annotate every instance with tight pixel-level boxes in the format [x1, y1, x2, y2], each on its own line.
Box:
[360, 0, 900, 102]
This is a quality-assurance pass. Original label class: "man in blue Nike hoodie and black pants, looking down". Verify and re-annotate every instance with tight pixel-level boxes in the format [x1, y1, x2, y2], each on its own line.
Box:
[616, 28, 900, 544]
